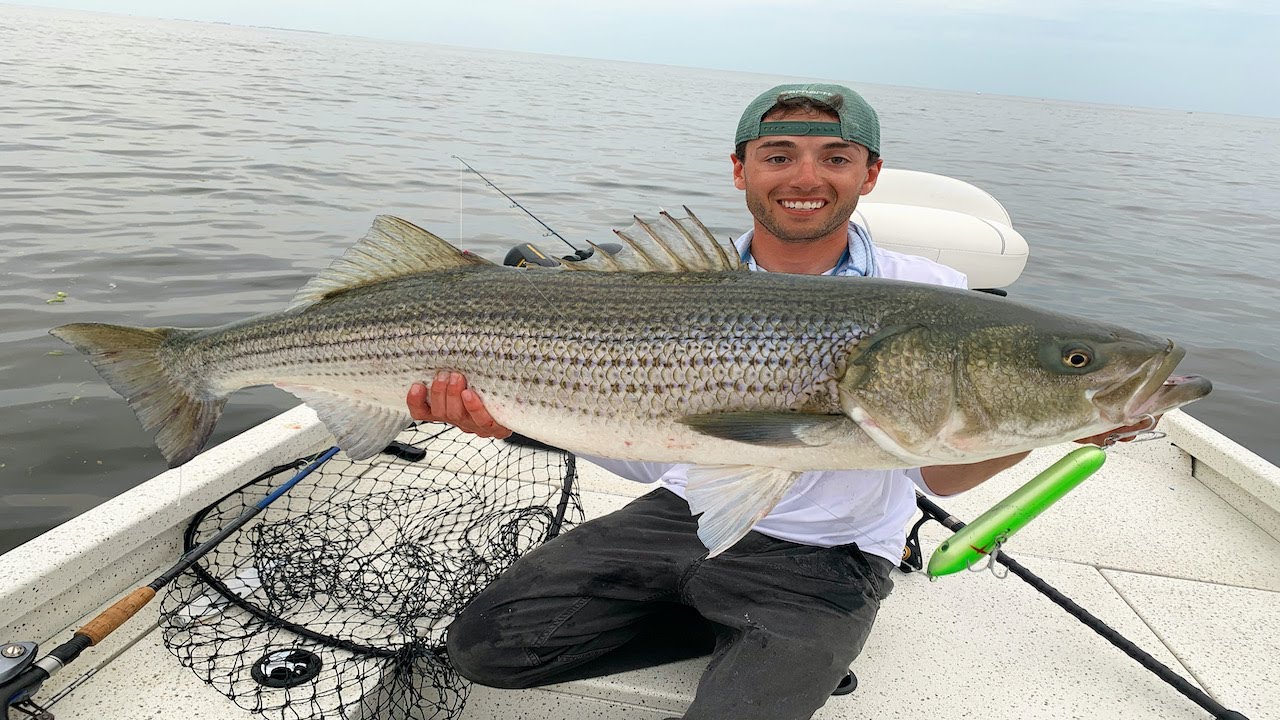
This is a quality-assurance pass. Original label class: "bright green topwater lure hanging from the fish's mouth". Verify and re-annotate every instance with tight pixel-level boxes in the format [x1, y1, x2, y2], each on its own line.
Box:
[927, 445, 1107, 578]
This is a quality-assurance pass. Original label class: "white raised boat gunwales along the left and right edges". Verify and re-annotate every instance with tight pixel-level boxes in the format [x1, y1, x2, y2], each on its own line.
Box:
[0, 405, 1280, 650]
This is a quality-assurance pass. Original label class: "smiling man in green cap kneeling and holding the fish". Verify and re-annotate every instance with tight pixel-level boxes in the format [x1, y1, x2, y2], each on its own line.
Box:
[407, 85, 1116, 720]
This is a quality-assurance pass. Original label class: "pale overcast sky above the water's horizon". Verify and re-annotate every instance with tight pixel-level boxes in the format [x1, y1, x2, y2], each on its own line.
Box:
[17, 0, 1280, 117]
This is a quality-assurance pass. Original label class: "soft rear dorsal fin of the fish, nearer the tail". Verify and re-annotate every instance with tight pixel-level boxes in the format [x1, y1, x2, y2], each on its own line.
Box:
[291, 210, 493, 307]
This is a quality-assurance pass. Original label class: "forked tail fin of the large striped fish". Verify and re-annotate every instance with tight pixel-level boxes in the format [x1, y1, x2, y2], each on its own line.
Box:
[49, 323, 227, 468]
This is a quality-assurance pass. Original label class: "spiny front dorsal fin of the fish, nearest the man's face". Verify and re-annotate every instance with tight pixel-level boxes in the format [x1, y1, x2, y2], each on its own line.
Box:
[562, 208, 745, 273]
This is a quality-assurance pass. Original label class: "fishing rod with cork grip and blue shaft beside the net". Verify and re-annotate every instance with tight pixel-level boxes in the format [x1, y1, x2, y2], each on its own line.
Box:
[0, 447, 338, 720]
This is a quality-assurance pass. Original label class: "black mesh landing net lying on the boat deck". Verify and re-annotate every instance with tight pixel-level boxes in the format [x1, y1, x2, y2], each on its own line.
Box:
[161, 424, 582, 720]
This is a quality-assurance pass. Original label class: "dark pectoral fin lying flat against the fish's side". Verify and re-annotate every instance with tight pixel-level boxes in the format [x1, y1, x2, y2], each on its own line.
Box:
[680, 413, 859, 447]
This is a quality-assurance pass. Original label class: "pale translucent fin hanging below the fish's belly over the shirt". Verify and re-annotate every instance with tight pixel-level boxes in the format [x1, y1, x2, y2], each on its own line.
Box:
[685, 465, 800, 557]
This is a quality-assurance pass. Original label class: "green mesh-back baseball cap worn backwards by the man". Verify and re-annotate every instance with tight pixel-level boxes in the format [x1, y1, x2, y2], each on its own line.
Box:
[733, 82, 879, 155]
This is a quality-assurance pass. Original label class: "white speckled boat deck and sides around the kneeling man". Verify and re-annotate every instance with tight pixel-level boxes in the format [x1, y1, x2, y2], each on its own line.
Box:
[0, 409, 1280, 720]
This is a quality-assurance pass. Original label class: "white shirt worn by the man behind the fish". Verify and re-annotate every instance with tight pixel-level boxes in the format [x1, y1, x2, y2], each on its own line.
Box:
[584, 224, 968, 565]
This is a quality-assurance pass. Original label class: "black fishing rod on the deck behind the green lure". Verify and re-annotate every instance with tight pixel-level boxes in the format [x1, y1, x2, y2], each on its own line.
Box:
[900, 481, 1248, 720]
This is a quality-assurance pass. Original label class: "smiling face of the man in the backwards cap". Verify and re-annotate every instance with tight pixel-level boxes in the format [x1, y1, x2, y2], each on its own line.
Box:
[733, 110, 881, 243]
